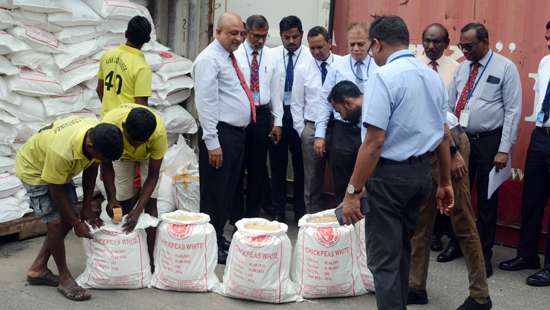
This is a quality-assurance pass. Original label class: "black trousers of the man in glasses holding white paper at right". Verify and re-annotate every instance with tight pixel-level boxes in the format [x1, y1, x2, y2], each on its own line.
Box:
[468, 128, 502, 265]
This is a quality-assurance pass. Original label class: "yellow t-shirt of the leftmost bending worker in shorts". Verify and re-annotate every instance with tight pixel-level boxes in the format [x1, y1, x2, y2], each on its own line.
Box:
[15, 116, 99, 185]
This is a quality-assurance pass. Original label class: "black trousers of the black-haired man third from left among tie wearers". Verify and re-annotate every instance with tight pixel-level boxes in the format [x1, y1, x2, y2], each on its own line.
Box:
[269, 106, 305, 215]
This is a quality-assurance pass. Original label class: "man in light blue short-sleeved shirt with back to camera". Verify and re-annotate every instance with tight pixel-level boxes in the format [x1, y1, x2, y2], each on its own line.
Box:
[338, 16, 454, 310]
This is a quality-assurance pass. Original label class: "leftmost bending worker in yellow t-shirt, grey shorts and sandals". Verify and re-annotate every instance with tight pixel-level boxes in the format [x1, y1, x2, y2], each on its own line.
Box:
[15, 116, 123, 300]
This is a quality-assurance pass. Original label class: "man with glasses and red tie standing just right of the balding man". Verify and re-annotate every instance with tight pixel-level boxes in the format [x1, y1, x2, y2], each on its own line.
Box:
[231, 15, 283, 221]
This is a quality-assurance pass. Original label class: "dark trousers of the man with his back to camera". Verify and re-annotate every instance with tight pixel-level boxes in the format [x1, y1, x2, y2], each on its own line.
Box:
[363, 156, 432, 310]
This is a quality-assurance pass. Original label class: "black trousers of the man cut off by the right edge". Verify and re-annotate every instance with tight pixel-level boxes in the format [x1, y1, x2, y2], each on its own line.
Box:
[518, 127, 550, 269]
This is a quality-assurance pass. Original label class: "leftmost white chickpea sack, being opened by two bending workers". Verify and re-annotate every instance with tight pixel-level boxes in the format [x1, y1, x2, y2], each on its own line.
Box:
[76, 202, 158, 289]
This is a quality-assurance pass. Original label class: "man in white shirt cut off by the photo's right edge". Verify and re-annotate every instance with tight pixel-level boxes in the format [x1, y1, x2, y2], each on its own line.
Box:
[499, 21, 550, 286]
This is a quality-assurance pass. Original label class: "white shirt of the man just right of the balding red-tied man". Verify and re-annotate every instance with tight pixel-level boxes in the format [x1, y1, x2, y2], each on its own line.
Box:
[235, 41, 283, 127]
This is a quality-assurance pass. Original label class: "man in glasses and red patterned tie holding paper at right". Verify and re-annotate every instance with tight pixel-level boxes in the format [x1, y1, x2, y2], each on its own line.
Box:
[449, 23, 521, 277]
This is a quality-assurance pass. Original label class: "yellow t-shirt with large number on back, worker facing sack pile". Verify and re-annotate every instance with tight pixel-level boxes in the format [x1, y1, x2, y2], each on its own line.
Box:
[97, 44, 152, 116]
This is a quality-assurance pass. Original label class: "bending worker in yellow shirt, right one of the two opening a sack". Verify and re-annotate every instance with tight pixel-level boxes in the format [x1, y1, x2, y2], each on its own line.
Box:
[101, 103, 168, 261]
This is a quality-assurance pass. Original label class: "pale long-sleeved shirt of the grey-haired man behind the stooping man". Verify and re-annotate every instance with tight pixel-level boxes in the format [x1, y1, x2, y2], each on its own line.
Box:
[315, 54, 378, 139]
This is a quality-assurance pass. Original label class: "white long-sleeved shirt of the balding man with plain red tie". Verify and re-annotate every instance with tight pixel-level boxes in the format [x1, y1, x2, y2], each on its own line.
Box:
[192, 40, 251, 150]
